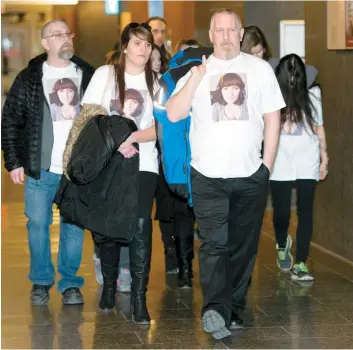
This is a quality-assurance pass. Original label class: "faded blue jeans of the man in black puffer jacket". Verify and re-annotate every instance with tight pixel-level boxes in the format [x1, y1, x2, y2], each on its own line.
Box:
[25, 170, 84, 293]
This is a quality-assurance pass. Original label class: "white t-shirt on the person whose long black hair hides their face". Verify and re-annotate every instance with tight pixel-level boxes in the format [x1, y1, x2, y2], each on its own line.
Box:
[271, 87, 324, 181]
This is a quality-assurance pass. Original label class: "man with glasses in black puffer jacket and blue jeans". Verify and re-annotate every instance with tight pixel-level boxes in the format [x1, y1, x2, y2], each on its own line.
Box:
[1, 20, 94, 305]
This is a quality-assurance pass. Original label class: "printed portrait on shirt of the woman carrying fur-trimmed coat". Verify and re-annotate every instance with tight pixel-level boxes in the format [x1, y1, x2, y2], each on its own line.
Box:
[110, 89, 147, 129]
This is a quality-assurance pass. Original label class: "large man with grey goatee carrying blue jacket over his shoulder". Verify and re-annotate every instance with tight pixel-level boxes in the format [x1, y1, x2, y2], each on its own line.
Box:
[165, 9, 285, 339]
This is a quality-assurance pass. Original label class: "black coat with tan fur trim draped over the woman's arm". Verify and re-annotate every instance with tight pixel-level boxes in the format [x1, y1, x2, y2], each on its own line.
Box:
[54, 105, 139, 243]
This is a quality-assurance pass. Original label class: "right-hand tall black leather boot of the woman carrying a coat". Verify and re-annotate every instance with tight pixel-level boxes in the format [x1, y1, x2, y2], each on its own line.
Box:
[130, 218, 152, 325]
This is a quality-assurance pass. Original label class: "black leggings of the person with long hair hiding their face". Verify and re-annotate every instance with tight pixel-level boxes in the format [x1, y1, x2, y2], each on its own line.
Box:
[270, 179, 316, 262]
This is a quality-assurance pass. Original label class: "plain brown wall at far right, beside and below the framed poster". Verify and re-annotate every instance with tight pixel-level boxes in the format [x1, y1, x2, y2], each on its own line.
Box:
[305, 1, 353, 261]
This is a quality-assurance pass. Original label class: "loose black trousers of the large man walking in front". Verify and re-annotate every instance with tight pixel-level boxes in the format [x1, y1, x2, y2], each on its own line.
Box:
[191, 165, 269, 324]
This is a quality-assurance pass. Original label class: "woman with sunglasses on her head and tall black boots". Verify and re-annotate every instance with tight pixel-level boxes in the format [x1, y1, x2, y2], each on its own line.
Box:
[82, 23, 158, 324]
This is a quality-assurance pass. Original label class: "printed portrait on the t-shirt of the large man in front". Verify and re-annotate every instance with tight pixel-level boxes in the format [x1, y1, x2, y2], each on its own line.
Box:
[210, 73, 249, 122]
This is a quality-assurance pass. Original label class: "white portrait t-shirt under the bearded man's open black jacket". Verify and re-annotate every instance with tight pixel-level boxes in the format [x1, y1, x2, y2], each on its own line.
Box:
[42, 62, 82, 174]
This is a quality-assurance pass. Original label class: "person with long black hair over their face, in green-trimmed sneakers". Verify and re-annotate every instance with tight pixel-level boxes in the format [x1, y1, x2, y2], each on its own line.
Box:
[270, 54, 328, 281]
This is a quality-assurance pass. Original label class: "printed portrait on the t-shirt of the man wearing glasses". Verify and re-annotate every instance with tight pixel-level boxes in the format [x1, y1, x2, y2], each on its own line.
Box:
[46, 78, 80, 121]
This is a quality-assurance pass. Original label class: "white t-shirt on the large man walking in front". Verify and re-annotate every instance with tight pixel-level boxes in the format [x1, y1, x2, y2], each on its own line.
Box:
[174, 52, 285, 178]
